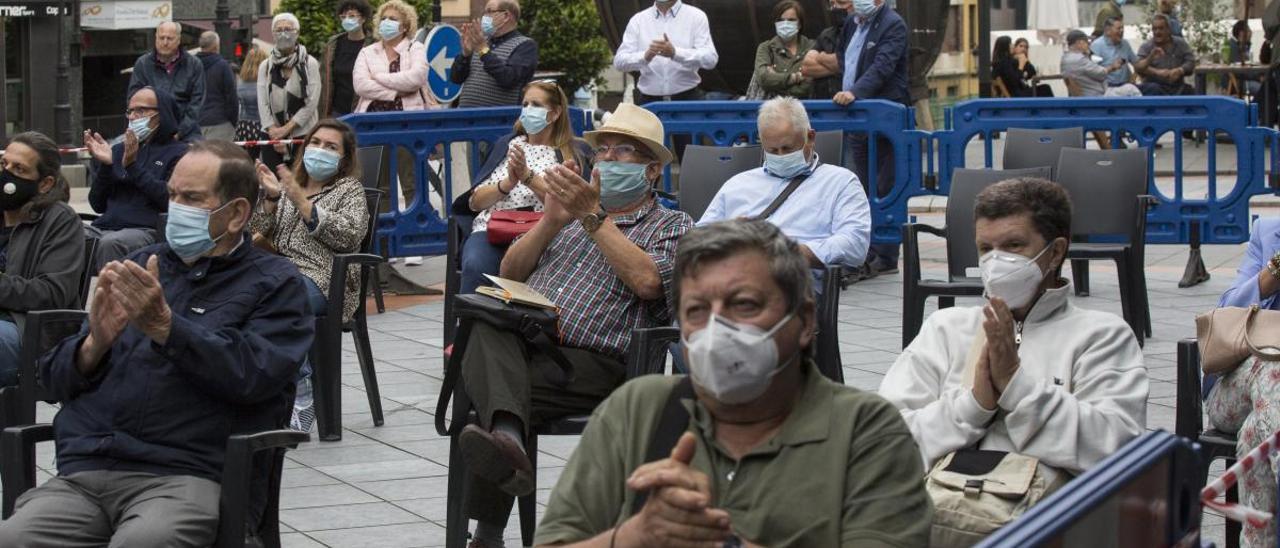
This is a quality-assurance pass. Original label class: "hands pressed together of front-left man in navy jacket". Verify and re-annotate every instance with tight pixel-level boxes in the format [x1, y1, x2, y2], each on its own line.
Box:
[78, 255, 173, 370]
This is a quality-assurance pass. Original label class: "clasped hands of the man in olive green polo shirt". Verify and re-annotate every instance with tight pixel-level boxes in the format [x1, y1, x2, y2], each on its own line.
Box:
[613, 431, 753, 548]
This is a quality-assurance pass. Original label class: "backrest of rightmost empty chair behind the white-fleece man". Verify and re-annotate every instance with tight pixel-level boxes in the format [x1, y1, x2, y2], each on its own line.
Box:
[1057, 147, 1148, 236]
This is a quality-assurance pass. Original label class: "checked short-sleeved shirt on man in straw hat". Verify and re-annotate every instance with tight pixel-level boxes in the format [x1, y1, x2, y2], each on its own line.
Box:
[527, 200, 694, 360]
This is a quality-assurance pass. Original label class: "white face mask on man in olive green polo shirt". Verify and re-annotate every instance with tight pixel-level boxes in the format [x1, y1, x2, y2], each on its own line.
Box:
[685, 312, 795, 405]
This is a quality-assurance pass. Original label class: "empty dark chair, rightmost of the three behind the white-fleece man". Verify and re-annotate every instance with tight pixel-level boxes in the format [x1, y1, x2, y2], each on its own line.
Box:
[1057, 147, 1156, 344]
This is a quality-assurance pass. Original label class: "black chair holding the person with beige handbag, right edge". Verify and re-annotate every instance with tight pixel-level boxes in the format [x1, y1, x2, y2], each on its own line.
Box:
[1174, 339, 1233, 548]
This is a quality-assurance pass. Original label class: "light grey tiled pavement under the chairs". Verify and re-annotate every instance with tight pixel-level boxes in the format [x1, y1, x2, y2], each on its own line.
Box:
[10, 206, 1244, 548]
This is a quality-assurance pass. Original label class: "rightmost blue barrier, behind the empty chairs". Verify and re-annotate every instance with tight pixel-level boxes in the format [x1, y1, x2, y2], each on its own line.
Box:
[925, 96, 1277, 243]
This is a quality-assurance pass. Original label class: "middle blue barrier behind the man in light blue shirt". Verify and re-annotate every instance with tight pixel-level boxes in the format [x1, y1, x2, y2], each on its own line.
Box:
[645, 100, 931, 243]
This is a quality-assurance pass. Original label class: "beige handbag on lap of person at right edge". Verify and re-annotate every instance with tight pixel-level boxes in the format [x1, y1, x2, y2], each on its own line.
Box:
[1196, 305, 1280, 374]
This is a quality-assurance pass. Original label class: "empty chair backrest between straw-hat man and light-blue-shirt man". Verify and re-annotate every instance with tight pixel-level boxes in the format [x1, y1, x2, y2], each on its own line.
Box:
[680, 145, 764, 222]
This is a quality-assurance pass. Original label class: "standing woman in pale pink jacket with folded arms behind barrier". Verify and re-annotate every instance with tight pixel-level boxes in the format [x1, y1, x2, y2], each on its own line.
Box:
[352, 0, 438, 265]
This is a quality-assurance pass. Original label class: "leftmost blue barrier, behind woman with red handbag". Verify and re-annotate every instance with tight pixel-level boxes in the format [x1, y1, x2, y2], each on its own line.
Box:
[343, 106, 588, 257]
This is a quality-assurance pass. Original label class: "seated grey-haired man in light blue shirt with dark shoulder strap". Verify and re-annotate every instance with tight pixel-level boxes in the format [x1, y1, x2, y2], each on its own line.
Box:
[698, 97, 872, 269]
